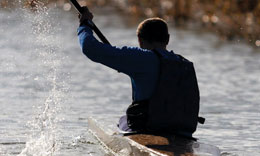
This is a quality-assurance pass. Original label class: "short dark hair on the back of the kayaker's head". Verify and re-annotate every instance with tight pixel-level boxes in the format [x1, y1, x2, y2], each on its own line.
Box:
[136, 17, 169, 44]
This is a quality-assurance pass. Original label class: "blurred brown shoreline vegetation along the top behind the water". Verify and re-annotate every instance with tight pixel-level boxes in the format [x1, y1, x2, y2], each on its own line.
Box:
[0, 0, 260, 47]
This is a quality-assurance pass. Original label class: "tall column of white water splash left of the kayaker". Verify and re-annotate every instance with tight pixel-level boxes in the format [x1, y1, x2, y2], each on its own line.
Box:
[19, 3, 66, 156]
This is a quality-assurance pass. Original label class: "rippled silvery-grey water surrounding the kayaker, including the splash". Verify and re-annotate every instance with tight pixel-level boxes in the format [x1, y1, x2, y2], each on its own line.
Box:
[0, 5, 260, 156]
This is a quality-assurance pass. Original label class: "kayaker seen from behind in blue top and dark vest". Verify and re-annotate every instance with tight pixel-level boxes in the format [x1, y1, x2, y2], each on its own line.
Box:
[78, 7, 203, 136]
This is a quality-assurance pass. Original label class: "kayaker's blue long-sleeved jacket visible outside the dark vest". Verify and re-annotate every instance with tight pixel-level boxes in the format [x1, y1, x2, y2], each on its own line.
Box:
[78, 26, 176, 101]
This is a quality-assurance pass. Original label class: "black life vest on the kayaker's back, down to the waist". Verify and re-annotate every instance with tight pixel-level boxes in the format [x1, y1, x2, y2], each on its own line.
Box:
[126, 50, 205, 133]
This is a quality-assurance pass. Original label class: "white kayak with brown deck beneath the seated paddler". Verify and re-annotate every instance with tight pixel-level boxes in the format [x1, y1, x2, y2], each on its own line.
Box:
[88, 118, 220, 156]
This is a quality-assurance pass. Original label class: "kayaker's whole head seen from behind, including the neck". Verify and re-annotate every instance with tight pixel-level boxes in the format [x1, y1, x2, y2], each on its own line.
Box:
[137, 18, 170, 50]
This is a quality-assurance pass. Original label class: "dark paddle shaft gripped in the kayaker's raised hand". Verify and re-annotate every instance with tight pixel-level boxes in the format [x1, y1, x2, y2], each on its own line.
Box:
[70, 0, 111, 45]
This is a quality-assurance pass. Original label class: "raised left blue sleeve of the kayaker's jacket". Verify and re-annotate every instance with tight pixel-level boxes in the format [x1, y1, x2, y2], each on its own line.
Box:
[78, 26, 156, 75]
